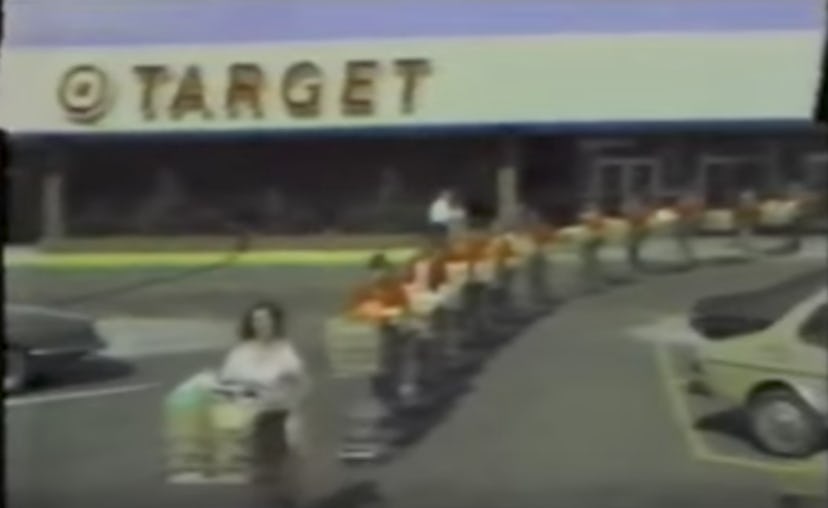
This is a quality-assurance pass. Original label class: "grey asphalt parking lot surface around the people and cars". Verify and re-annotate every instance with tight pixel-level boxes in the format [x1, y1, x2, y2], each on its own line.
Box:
[5, 240, 824, 508]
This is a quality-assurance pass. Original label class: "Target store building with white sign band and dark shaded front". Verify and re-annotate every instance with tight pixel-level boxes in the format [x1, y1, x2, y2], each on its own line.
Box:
[0, 0, 828, 242]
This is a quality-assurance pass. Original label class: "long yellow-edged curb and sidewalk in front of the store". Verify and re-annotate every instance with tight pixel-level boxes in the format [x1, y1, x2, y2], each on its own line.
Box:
[3, 236, 828, 269]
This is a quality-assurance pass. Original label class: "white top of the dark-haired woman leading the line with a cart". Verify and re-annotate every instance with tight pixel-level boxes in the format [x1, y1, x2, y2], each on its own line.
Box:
[219, 340, 310, 411]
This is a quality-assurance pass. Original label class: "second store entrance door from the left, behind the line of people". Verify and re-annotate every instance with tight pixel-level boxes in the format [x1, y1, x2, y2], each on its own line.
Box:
[700, 155, 768, 208]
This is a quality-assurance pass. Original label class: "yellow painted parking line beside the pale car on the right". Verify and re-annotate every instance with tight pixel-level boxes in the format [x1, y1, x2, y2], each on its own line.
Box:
[653, 344, 822, 474]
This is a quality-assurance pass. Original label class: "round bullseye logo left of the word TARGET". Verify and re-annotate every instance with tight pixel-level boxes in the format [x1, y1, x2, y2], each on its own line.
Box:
[58, 65, 113, 124]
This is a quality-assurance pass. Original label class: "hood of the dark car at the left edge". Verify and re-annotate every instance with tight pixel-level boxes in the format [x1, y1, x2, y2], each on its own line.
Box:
[4, 304, 103, 349]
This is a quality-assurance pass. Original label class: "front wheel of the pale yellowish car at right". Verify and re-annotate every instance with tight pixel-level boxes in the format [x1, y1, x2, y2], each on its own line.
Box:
[748, 389, 824, 457]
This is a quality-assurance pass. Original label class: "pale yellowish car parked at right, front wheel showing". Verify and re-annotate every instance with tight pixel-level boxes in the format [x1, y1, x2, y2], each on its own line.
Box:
[696, 288, 828, 457]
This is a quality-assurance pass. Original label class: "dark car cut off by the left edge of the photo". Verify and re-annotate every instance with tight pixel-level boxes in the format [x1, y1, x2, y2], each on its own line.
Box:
[3, 304, 104, 393]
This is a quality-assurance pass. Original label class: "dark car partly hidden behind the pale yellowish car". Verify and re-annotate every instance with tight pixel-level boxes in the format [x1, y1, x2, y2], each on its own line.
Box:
[690, 269, 828, 340]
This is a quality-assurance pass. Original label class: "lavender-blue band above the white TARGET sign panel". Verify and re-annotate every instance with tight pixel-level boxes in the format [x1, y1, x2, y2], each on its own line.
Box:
[5, 0, 825, 47]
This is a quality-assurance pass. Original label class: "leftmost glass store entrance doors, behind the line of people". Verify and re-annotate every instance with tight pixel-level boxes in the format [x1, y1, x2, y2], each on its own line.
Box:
[589, 157, 661, 213]
